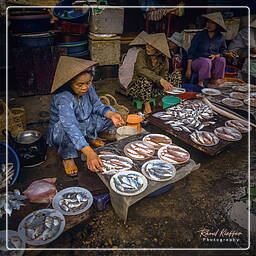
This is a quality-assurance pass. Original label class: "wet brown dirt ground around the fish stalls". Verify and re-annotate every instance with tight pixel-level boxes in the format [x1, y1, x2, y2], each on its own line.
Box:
[2, 79, 256, 256]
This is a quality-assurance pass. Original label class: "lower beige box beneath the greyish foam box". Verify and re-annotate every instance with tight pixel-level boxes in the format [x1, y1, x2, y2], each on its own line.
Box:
[89, 34, 121, 66]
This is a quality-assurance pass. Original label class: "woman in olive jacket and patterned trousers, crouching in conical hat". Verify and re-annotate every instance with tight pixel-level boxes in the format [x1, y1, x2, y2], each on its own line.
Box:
[127, 33, 173, 114]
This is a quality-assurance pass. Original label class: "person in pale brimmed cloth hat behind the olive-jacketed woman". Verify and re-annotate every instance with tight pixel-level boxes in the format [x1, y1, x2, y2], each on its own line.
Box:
[167, 32, 188, 87]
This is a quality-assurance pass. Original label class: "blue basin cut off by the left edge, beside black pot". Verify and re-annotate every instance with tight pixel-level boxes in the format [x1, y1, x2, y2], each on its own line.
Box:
[0, 142, 20, 185]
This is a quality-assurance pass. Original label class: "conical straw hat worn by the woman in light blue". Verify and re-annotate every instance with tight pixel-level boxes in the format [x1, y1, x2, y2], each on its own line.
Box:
[51, 56, 97, 93]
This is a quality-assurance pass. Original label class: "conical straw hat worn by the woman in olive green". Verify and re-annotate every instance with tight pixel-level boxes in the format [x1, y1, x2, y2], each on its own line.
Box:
[142, 33, 171, 58]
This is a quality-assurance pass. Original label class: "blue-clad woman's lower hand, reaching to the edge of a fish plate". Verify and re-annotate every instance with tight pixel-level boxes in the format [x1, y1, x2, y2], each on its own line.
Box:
[81, 146, 103, 172]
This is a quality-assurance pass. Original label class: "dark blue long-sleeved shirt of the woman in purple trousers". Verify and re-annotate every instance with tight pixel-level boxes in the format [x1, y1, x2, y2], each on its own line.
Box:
[188, 29, 227, 60]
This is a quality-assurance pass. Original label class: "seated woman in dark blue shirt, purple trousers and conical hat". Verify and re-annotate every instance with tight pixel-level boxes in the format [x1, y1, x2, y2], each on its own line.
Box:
[186, 12, 235, 87]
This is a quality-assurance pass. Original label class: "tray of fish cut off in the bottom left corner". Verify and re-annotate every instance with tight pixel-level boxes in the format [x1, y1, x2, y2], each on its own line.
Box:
[0, 230, 26, 256]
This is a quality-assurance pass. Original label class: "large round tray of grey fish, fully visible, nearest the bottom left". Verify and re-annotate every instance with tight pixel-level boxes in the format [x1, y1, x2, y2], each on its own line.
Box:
[18, 209, 65, 245]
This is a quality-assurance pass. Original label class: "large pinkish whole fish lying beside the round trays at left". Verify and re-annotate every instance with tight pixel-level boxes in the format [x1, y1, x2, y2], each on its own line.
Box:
[23, 178, 57, 203]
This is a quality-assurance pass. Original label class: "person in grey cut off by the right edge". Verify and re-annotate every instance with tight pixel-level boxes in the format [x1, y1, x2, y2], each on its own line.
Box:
[229, 19, 256, 83]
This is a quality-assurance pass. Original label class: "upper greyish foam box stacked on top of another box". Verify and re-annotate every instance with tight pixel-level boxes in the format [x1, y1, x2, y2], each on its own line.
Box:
[90, 7, 124, 34]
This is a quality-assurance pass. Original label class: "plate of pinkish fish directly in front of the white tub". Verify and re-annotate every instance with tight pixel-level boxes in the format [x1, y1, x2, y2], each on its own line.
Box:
[124, 141, 155, 160]
